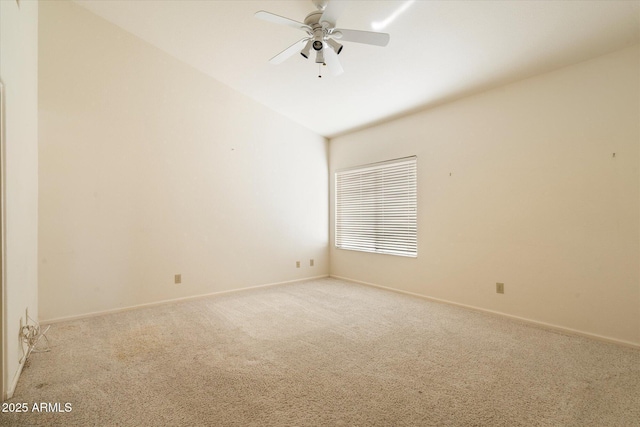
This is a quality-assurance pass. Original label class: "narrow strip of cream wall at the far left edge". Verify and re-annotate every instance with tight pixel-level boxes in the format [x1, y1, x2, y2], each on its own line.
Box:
[0, 1, 38, 395]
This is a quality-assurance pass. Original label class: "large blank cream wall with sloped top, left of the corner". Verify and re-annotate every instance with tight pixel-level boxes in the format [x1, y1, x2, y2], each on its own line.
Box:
[39, 2, 329, 320]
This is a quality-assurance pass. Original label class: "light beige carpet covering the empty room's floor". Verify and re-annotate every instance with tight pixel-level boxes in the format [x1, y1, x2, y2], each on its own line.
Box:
[0, 279, 640, 426]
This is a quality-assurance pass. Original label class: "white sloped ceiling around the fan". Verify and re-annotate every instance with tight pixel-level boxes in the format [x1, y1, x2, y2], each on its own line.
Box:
[76, 0, 640, 137]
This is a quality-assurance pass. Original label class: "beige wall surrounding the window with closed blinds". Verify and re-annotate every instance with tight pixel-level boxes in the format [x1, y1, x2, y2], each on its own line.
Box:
[330, 46, 640, 345]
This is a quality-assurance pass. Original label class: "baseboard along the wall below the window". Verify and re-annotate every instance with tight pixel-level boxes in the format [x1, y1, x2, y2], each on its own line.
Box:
[329, 274, 640, 349]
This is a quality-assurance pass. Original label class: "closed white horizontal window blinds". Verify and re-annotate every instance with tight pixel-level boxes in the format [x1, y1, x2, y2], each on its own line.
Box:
[335, 157, 418, 257]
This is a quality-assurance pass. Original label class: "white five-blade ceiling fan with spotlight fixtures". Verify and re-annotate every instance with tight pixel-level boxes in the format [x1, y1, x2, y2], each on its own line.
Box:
[255, 0, 389, 77]
